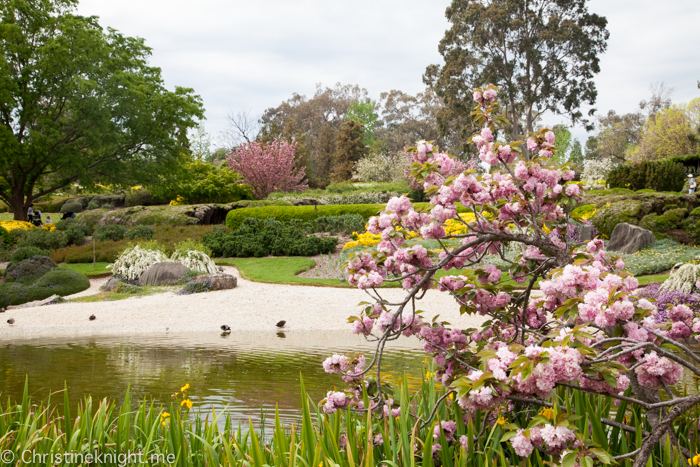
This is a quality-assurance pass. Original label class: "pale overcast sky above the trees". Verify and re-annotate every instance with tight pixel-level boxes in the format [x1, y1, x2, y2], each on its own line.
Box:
[78, 0, 700, 146]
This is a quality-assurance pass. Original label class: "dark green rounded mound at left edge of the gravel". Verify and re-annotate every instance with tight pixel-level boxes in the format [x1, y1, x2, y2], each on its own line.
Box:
[0, 269, 90, 308]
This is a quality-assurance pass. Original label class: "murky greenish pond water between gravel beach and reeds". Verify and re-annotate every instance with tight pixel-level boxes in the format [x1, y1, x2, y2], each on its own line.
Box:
[0, 332, 426, 423]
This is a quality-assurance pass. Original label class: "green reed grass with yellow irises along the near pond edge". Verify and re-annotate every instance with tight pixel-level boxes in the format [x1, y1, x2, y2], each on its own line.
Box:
[0, 377, 698, 467]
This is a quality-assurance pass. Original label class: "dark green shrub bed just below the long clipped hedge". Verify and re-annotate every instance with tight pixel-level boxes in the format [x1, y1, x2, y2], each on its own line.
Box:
[204, 218, 338, 258]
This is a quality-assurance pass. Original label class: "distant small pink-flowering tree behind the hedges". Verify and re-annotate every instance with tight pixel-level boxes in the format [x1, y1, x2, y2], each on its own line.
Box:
[226, 140, 309, 199]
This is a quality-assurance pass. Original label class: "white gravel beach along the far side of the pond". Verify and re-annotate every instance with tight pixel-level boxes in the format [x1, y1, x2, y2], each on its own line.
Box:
[0, 267, 484, 340]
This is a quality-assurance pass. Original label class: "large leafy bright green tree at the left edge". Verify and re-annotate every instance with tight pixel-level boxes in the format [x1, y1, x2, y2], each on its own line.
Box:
[0, 0, 202, 220]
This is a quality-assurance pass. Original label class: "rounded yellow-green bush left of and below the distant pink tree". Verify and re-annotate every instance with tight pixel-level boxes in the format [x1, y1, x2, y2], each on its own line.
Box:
[149, 159, 253, 204]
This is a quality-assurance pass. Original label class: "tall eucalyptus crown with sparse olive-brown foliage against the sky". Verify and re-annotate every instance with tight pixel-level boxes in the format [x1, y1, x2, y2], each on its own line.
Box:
[424, 0, 609, 141]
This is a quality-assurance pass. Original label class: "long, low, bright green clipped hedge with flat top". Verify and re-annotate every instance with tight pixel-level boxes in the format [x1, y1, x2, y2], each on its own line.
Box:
[226, 203, 465, 230]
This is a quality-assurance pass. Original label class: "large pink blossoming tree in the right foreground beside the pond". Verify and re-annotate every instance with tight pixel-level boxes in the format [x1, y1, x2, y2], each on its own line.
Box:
[323, 86, 700, 466]
